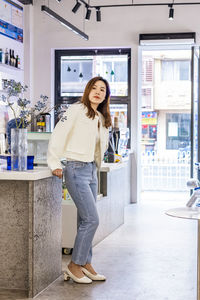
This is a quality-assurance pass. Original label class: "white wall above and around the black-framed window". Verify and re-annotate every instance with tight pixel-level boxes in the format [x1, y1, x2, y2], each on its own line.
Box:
[25, 0, 200, 202]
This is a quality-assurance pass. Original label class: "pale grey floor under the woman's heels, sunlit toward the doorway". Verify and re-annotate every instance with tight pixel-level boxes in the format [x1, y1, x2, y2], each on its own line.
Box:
[0, 193, 197, 300]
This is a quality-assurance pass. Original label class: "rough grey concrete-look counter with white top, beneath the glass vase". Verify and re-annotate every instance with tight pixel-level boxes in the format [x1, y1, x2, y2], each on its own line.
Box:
[0, 168, 62, 297]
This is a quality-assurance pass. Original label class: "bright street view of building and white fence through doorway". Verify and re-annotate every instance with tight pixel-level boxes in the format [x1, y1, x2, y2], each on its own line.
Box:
[141, 50, 191, 191]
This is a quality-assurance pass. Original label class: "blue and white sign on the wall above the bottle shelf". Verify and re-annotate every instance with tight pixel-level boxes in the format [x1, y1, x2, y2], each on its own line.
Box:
[0, 0, 23, 43]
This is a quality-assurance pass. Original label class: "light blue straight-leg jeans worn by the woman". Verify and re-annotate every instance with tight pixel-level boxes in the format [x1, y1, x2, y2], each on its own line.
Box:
[64, 161, 99, 265]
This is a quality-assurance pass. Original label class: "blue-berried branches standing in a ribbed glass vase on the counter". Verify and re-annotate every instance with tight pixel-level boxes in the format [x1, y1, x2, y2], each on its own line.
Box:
[1, 80, 66, 171]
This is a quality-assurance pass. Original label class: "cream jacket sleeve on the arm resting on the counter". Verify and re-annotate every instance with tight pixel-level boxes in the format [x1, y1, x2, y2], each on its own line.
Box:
[47, 104, 78, 170]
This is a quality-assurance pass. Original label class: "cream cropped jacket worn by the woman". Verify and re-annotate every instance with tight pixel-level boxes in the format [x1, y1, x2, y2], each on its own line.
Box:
[47, 103, 109, 170]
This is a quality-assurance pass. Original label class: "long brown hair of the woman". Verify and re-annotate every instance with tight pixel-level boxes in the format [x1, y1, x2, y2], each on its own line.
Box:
[81, 76, 112, 128]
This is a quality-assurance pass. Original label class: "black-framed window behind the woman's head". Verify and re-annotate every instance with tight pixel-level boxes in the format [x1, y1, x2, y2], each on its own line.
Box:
[54, 48, 131, 147]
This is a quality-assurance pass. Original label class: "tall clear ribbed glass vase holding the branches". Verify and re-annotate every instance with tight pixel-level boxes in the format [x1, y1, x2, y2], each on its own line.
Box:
[11, 128, 28, 171]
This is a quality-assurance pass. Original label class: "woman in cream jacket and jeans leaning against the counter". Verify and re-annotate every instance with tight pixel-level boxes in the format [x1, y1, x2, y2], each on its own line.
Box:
[47, 77, 111, 283]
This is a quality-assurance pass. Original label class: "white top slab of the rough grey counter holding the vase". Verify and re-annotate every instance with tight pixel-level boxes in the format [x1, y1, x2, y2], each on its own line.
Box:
[0, 167, 52, 181]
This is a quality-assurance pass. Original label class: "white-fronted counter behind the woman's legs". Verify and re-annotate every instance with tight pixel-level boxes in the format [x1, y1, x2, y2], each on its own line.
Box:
[62, 159, 131, 248]
